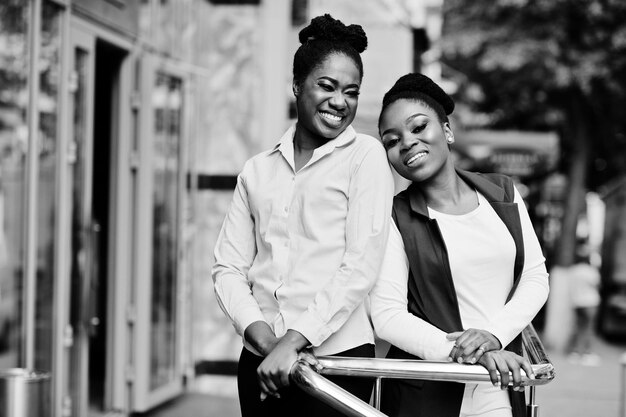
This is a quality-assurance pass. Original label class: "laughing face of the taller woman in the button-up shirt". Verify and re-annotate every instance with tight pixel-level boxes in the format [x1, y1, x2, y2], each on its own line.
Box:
[294, 54, 361, 141]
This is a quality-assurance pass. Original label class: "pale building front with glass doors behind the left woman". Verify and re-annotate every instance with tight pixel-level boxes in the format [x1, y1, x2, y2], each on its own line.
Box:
[0, 0, 441, 417]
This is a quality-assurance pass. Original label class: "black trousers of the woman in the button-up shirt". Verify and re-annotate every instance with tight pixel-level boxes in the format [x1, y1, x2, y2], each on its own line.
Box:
[237, 344, 375, 417]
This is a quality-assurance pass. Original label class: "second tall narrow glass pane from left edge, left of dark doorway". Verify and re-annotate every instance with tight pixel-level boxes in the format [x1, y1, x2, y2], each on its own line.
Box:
[34, 2, 61, 370]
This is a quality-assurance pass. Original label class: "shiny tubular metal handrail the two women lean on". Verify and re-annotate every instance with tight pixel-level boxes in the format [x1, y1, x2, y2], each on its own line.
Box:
[291, 325, 555, 417]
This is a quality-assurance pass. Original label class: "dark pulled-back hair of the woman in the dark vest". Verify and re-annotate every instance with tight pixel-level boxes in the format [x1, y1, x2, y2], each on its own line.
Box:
[379, 73, 454, 124]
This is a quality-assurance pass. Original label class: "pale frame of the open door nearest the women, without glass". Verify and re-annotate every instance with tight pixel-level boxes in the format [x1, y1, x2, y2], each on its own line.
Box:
[132, 54, 190, 412]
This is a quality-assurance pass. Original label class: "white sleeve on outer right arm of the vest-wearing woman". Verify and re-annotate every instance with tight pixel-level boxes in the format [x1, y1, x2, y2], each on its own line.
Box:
[485, 189, 549, 347]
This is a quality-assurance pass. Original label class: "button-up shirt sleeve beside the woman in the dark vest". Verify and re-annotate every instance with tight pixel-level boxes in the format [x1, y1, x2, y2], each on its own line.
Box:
[291, 143, 394, 346]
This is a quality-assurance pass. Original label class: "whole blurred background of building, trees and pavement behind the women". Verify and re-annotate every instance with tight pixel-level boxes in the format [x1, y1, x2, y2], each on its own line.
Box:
[0, 0, 626, 417]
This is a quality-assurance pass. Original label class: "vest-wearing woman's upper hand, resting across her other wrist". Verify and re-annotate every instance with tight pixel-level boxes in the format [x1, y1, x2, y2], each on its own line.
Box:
[446, 329, 502, 364]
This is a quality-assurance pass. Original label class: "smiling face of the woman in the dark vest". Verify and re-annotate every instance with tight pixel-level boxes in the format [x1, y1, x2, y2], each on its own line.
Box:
[379, 99, 454, 182]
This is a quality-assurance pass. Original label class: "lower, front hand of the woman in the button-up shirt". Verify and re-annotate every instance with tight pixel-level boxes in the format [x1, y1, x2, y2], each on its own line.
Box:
[257, 330, 309, 400]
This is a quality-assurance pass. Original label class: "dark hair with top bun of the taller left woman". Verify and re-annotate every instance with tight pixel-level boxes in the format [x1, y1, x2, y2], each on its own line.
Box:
[293, 14, 367, 84]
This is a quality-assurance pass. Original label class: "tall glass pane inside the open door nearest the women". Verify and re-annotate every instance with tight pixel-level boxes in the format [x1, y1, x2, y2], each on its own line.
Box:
[150, 74, 182, 389]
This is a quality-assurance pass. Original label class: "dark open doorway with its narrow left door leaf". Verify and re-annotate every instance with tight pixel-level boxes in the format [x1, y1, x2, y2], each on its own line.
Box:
[69, 25, 126, 417]
